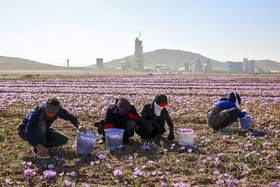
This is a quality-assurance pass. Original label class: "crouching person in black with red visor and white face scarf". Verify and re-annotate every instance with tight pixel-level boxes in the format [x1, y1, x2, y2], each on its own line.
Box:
[136, 94, 174, 141]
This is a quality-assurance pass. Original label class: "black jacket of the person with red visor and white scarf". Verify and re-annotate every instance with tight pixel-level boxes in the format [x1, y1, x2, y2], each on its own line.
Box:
[139, 101, 173, 133]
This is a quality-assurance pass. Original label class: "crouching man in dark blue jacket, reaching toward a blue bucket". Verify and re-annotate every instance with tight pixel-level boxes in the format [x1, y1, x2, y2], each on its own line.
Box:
[18, 98, 87, 159]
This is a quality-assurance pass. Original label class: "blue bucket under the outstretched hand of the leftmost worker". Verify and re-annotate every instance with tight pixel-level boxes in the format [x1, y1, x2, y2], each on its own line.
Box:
[77, 130, 98, 155]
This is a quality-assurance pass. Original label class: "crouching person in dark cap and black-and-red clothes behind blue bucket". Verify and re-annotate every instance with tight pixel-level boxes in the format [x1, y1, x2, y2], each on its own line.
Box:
[94, 97, 139, 143]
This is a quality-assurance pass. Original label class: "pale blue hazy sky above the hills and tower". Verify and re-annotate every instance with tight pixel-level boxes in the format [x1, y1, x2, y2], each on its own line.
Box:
[0, 0, 280, 66]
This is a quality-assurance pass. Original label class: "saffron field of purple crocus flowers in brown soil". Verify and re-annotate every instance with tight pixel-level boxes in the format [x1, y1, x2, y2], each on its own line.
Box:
[0, 76, 280, 186]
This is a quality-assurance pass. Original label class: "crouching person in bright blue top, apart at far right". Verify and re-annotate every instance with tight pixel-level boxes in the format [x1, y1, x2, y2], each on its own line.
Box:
[206, 92, 248, 134]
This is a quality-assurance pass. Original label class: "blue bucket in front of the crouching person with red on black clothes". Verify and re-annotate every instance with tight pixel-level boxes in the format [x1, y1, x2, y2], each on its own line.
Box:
[104, 128, 124, 151]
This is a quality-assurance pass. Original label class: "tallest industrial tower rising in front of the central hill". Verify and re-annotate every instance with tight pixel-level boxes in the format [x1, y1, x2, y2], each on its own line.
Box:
[134, 38, 144, 71]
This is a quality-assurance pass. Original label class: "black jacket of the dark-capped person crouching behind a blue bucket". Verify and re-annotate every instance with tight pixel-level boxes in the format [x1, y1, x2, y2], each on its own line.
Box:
[104, 104, 139, 128]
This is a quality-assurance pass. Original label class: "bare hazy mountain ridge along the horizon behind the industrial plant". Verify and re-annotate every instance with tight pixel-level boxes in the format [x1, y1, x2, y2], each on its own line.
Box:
[0, 49, 280, 72]
